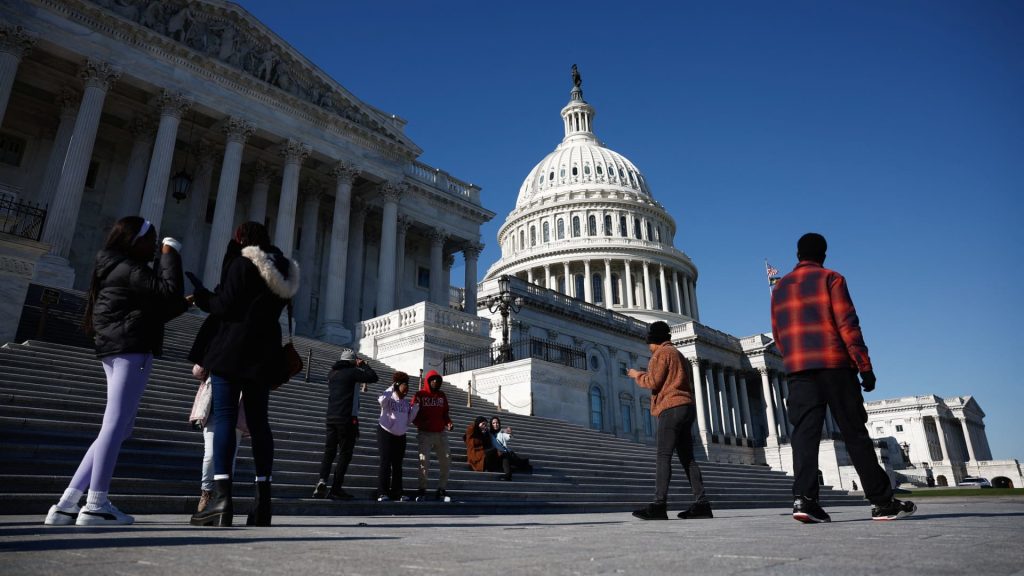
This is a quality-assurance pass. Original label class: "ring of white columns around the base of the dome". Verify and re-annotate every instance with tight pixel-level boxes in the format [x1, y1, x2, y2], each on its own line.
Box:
[524, 258, 699, 320]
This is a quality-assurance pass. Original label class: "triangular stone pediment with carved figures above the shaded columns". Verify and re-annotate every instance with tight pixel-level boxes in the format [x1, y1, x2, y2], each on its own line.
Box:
[82, 0, 420, 156]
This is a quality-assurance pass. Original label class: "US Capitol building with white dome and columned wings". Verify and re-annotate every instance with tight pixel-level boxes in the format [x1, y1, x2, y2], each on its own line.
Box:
[0, 0, 1024, 490]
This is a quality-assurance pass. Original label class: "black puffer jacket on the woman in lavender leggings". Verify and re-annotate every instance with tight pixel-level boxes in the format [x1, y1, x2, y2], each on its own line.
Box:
[92, 250, 187, 358]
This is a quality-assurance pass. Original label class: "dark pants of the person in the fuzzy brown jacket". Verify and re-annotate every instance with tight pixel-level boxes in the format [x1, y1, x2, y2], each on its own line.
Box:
[654, 404, 708, 504]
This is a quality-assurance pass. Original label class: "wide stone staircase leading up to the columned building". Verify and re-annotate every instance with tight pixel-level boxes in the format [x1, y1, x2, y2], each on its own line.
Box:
[0, 305, 863, 517]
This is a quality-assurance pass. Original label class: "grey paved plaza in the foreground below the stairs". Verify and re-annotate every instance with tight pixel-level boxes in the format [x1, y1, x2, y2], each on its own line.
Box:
[0, 497, 1024, 576]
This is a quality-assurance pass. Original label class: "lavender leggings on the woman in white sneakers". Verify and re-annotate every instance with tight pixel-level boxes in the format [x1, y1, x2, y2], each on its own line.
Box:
[70, 354, 153, 492]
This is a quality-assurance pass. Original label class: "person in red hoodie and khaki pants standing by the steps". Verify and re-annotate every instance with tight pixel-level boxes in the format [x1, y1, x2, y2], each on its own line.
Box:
[413, 370, 452, 502]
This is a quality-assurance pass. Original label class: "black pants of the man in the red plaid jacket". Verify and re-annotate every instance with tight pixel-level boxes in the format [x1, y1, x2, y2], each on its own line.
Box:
[790, 368, 893, 504]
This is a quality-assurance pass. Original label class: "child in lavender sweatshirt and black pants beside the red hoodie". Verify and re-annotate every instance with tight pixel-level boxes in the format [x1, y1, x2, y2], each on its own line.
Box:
[377, 372, 420, 502]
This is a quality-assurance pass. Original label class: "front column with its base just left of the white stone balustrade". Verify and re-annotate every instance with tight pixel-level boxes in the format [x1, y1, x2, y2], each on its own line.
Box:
[321, 162, 359, 344]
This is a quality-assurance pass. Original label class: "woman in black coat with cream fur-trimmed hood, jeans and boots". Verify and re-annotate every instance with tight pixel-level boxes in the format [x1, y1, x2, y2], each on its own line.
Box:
[190, 221, 299, 526]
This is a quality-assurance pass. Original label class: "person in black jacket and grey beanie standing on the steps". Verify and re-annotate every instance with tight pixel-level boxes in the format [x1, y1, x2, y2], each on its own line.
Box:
[313, 348, 378, 500]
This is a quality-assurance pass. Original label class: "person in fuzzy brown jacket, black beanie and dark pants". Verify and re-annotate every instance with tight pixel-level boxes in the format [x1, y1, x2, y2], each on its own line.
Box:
[627, 321, 714, 520]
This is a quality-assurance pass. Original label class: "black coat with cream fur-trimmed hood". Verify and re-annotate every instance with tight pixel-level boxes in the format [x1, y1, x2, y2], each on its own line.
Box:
[194, 246, 299, 385]
